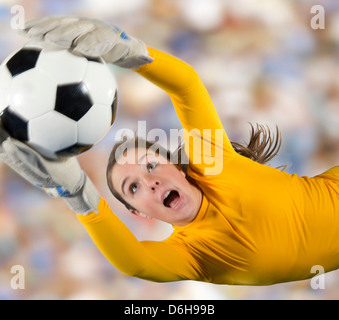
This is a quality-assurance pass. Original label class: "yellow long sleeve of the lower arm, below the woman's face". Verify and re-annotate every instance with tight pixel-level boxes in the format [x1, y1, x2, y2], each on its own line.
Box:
[78, 199, 202, 282]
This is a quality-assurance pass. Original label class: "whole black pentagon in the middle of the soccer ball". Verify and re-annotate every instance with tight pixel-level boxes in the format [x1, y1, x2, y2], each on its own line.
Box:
[55, 82, 93, 121]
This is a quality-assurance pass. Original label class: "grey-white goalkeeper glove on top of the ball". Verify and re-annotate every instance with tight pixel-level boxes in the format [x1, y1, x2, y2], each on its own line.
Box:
[24, 16, 153, 69]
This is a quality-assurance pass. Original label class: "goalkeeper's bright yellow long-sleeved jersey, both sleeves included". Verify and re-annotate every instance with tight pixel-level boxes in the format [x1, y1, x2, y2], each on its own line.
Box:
[78, 48, 339, 285]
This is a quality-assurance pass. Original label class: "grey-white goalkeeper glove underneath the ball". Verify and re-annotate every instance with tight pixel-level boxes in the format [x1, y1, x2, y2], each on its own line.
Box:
[0, 122, 100, 215]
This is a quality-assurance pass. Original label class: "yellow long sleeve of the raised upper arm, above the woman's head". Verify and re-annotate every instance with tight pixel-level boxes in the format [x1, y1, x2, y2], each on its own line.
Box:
[135, 47, 236, 176]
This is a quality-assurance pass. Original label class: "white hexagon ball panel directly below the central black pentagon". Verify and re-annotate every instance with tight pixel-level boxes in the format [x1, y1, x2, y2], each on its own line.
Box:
[28, 111, 78, 158]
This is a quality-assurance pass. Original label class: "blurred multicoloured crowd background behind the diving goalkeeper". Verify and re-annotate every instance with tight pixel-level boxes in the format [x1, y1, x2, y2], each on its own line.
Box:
[0, 0, 339, 299]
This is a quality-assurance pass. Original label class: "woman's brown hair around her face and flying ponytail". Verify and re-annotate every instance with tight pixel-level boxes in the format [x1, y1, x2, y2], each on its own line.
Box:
[106, 123, 286, 210]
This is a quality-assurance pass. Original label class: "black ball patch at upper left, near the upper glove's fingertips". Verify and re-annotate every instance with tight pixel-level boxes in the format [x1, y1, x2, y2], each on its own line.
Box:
[6, 48, 41, 77]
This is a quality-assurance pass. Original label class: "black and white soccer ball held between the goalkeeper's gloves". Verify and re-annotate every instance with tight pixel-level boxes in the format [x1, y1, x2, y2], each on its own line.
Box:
[0, 42, 118, 159]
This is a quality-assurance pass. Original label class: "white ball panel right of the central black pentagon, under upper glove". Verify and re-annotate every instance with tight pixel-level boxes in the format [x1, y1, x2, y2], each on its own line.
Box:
[83, 61, 117, 105]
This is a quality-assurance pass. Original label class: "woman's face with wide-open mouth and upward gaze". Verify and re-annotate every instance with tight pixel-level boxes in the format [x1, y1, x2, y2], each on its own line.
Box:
[111, 148, 202, 226]
